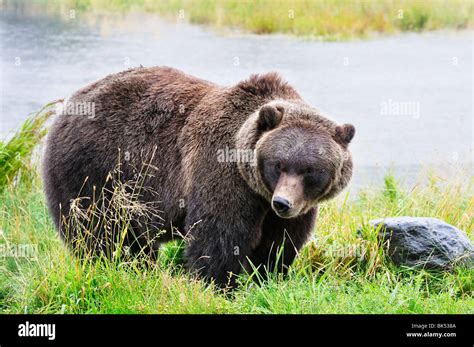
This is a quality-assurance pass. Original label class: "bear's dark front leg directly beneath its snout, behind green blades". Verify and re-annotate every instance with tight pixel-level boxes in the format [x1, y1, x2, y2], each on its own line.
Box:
[246, 208, 317, 279]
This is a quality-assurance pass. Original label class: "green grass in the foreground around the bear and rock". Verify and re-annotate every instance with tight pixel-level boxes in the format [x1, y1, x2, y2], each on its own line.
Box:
[0, 164, 474, 313]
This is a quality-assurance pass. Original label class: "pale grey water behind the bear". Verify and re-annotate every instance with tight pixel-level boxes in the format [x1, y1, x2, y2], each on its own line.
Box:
[0, 2, 474, 187]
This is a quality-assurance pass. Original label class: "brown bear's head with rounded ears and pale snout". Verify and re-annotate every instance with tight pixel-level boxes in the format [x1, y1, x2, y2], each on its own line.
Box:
[236, 100, 355, 218]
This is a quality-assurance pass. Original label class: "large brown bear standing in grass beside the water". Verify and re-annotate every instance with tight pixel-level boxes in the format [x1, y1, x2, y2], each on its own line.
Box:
[43, 67, 355, 286]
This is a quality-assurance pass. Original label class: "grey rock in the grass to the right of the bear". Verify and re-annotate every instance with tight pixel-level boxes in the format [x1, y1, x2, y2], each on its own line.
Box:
[370, 217, 474, 269]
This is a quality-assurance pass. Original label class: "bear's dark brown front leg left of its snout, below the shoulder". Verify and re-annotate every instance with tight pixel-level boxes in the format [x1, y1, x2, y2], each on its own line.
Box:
[185, 189, 265, 288]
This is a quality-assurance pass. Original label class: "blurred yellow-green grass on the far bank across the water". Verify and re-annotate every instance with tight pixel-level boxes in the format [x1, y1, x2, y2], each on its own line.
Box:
[44, 0, 474, 40]
